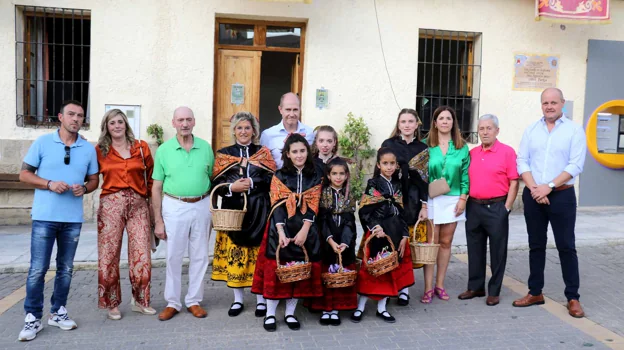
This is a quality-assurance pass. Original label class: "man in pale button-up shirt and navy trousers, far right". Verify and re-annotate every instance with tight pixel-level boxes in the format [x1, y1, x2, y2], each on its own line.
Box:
[513, 88, 587, 318]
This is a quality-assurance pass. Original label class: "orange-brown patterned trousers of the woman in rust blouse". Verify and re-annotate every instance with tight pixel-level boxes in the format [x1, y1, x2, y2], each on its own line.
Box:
[98, 189, 152, 309]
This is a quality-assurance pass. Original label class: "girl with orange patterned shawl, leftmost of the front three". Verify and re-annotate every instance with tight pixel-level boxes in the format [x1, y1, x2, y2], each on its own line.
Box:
[251, 134, 323, 332]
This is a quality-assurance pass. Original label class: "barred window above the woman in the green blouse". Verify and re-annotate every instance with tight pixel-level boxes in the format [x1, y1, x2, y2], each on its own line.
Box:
[416, 29, 481, 143]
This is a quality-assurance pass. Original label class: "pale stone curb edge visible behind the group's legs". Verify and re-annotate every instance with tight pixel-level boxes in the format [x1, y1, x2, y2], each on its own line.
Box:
[0, 238, 624, 273]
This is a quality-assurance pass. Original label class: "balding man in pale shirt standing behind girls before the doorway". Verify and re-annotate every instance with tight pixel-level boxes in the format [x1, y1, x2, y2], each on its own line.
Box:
[260, 92, 314, 169]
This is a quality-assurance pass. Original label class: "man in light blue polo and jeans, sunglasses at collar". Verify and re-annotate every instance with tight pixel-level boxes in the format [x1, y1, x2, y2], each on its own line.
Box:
[18, 101, 99, 341]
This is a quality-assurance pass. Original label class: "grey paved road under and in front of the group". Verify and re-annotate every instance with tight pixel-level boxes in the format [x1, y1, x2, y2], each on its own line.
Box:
[0, 247, 624, 350]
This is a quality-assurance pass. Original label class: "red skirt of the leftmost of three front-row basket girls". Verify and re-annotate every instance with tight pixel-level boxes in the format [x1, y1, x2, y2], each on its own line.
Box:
[251, 224, 323, 299]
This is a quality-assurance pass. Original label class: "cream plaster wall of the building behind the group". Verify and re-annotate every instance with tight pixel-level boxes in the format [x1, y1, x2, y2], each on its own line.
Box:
[0, 0, 624, 147]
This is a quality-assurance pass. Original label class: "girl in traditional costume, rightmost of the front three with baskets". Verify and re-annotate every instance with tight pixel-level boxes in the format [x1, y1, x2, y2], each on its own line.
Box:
[351, 147, 414, 323]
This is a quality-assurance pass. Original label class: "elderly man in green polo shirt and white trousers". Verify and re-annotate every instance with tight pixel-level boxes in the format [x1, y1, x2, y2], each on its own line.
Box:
[152, 107, 214, 321]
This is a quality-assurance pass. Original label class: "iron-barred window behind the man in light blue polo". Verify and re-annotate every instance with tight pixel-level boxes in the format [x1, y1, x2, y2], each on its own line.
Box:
[15, 6, 91, 128]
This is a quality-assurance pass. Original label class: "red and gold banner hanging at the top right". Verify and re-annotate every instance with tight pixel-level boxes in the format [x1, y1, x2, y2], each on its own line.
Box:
[535, 0, 611, 23]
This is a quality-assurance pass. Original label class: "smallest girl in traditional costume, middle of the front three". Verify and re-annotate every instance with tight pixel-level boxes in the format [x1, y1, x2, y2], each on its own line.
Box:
[308, 157, 357, 326]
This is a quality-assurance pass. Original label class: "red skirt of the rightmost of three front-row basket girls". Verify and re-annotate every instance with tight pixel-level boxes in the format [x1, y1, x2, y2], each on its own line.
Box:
[357, 231, 414, 300]
